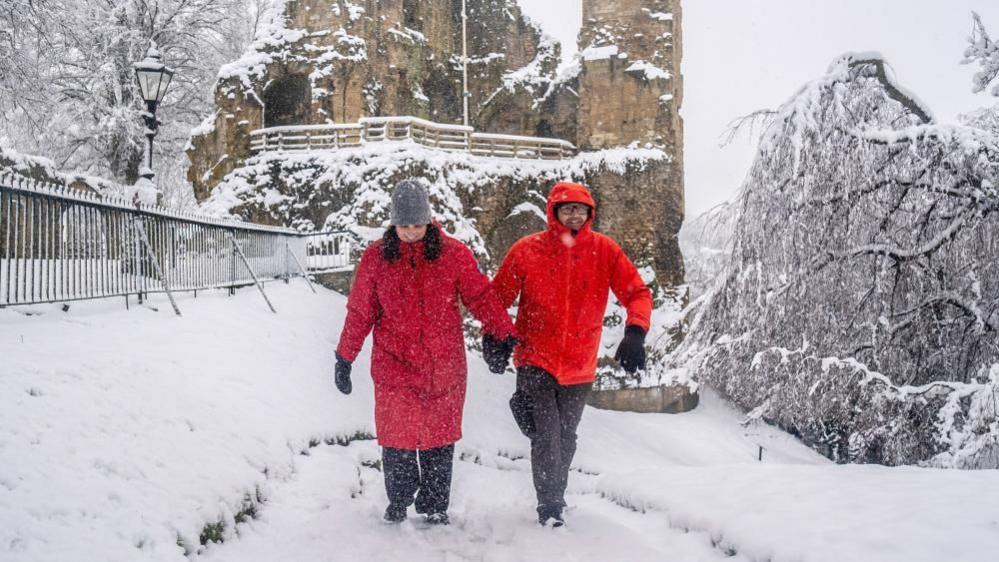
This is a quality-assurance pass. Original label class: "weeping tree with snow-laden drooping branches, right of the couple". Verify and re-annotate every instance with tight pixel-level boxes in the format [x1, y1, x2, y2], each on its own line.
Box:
[678, 54, 999, 468]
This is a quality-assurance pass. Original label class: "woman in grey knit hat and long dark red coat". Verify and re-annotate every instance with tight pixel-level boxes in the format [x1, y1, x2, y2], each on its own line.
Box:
[336, 181, 514, 524]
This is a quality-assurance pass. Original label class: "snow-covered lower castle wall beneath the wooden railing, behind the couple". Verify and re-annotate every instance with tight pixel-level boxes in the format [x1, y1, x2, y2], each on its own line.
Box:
[202, 141, 675, 270]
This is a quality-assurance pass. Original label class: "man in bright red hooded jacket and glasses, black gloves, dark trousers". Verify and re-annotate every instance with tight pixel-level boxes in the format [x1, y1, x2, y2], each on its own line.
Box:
[483, 182, 652, 527]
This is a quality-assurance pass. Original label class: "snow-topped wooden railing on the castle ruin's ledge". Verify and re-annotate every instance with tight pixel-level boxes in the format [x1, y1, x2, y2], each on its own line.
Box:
[250, 117, 576, 160]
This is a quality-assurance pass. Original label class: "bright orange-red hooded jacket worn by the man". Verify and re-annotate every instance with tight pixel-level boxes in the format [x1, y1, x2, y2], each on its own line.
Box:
[493, 183, 652, 385]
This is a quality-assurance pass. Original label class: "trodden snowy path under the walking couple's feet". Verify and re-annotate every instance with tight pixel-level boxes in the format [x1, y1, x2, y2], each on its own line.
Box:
[203, 441, 740, 562]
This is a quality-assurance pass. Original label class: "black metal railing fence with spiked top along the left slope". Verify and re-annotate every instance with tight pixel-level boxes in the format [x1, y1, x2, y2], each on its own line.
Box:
[0, 174, 352, 313]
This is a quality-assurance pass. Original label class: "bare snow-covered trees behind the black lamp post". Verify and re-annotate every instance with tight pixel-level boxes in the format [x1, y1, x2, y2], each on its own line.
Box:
[0, 0, 268, 206]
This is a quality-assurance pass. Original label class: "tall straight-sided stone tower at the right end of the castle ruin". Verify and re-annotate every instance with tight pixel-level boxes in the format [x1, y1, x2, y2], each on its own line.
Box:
[576, 0, 684, 283]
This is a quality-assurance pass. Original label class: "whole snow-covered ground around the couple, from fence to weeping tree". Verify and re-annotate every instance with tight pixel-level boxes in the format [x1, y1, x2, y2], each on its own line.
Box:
[0, 281, 999, 562]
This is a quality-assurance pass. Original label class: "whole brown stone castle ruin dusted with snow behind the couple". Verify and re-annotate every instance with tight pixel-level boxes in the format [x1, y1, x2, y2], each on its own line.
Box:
[188, 0, 683, 290]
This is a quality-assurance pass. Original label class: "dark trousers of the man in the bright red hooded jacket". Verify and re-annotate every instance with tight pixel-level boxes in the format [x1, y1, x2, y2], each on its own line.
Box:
[510, 365, 593, 513]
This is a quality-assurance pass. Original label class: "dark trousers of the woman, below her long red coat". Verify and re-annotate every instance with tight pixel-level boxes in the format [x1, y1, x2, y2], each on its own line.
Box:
[382, 445, 454, 514]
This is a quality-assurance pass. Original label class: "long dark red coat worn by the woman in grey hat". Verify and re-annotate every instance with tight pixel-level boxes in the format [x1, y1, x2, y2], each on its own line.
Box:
[337, 226, 514, 450]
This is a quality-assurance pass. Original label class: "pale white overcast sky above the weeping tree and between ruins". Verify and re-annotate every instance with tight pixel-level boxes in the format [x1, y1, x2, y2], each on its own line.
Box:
[518, 0, 999, 217]
